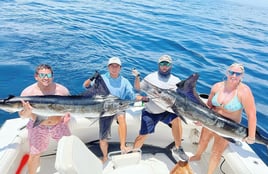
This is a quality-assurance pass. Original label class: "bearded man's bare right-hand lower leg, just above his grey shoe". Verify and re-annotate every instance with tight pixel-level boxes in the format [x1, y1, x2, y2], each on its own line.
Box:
[171, 118, 182, 148]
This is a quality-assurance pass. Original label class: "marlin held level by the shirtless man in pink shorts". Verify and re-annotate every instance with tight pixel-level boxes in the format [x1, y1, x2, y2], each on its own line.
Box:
[0, 72, 135, 125]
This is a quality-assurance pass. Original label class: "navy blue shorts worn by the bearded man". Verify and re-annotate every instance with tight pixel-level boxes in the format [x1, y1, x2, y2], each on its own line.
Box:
[140, 109, 178, 135]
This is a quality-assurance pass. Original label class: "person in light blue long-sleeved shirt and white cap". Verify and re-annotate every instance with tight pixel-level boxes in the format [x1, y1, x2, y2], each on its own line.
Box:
[83, 57, 142, 162]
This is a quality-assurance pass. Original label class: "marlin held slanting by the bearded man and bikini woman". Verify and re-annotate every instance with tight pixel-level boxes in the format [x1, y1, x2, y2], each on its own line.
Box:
[143, 73, 268, 146]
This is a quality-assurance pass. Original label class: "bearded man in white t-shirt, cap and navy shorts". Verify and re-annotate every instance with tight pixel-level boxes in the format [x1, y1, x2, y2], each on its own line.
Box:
[132, 55, 188, 161]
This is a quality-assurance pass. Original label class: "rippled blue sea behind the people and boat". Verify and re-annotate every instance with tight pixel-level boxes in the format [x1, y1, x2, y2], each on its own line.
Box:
[0, 0, 268, 164]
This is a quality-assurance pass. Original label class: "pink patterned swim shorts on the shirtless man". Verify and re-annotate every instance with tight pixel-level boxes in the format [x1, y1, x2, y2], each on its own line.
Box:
[27, 120, 71, 154]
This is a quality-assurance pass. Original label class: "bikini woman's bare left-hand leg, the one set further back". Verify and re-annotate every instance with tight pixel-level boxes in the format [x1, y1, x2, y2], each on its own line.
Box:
[190, 127, 213, 161]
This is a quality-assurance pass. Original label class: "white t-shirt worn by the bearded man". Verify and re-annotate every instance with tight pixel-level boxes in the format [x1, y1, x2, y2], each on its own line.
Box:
[141, 71, 180, 114]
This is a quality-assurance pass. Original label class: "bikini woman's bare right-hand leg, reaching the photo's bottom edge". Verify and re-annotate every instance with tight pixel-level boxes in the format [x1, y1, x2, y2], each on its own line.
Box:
[208, 134, 228, 174]
